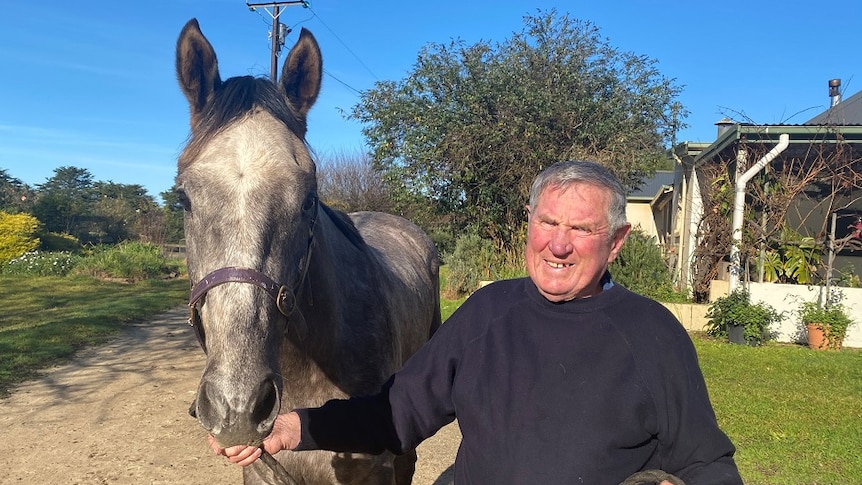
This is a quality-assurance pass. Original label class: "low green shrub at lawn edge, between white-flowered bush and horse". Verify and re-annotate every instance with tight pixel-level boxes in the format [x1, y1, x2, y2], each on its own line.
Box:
[75, 242, 175, 281]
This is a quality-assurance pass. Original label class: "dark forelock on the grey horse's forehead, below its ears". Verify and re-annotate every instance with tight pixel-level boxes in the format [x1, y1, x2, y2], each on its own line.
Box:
[179, 76, 307, 171]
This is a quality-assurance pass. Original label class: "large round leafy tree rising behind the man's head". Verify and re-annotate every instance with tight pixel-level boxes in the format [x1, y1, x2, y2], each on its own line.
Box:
[352, 10, 686, 247]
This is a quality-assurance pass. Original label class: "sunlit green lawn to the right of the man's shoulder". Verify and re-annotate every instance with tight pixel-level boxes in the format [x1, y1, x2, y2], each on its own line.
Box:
[694, 336, 862, 484]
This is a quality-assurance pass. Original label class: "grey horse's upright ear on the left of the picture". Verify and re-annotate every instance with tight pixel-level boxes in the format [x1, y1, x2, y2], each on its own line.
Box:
[177, 19, 221, 126]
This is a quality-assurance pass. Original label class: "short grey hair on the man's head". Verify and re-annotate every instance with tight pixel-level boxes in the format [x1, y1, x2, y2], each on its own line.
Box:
[530, 160, 628, 237]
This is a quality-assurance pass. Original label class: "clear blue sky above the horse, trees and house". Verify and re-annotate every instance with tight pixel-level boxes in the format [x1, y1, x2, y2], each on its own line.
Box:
[0, 0, 862, 200]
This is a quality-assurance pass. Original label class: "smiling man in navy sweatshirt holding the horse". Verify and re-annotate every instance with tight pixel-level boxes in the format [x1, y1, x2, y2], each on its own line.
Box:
[212, 162, 742, 485]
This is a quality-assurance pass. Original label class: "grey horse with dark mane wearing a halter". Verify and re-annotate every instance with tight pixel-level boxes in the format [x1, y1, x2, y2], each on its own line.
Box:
[175, 19, 440, 485]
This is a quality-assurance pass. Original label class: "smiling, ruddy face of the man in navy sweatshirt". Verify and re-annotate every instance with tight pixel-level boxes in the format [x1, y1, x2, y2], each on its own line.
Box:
[526, 184, 631, 302]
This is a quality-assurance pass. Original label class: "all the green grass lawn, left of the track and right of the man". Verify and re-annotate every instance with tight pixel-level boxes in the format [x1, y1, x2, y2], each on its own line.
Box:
[0, 275, 862, 485]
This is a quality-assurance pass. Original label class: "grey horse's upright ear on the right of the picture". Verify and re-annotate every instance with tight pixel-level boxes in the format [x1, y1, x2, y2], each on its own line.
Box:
[281, 28, 323, 118]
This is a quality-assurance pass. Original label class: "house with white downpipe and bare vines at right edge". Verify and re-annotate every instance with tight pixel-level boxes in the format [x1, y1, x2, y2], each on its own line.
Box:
[668, 80, 862, 296]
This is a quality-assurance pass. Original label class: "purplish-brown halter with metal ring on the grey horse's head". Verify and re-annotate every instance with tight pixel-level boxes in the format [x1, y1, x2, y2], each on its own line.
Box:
[189, 196, 318, 353]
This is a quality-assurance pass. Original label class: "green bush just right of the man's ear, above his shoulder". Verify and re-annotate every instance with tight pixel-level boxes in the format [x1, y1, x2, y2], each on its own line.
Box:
[610, 229, 689, 303]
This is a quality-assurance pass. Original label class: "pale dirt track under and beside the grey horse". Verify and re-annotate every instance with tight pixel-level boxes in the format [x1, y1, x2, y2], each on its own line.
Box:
[0, 308, 460, 485]
